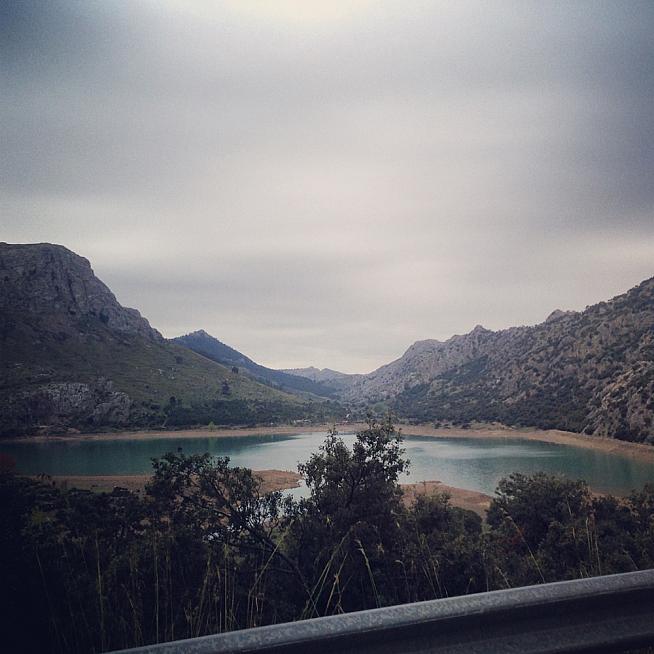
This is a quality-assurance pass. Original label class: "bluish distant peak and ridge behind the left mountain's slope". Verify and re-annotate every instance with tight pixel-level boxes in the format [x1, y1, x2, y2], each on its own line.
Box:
[172, 329, 336, 397]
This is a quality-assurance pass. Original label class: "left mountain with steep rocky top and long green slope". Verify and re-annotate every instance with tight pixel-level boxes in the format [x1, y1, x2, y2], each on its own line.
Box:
[0, 243, 334, 435]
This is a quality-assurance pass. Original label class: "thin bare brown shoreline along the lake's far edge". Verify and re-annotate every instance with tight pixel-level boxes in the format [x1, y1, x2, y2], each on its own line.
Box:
[6, 423, 654, 464]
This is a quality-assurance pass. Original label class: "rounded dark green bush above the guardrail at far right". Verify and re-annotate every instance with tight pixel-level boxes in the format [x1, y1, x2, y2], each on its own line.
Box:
[487, 473, 654, 586]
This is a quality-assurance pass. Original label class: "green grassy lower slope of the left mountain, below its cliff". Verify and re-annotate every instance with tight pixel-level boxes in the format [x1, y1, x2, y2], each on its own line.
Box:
[0, 320, 342, 436]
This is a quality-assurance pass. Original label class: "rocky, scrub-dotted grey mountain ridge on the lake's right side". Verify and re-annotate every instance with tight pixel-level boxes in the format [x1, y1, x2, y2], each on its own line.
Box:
[341, 278, 654, 442]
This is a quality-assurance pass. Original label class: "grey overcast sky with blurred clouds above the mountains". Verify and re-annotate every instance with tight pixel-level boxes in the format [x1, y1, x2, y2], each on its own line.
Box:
[0, 0, 654, 372]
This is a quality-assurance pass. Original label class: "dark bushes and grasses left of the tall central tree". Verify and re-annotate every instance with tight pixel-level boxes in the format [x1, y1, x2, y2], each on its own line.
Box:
[0, 454, 303, 652]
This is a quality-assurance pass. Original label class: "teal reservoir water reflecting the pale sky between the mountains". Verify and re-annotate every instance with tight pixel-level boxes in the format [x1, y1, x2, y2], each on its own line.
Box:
[0, 432, 654, 495]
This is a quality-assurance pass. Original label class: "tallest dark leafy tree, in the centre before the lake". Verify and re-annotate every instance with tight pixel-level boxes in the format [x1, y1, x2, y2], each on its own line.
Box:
[286, 418, 409, 616]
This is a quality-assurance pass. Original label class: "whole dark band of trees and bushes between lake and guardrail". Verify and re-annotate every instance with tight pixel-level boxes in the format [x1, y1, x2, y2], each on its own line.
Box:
[0, 421, 654, 652]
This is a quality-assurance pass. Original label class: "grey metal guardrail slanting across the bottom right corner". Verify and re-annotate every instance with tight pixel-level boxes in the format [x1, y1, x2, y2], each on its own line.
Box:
[113, 570, 654, 654]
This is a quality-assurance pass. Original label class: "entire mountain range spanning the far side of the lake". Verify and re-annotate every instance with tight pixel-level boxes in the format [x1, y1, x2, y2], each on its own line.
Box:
[0, 243, 654, 442]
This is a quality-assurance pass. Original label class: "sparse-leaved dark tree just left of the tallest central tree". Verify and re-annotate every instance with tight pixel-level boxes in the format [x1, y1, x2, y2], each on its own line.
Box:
[146, 453, 307, 628]
